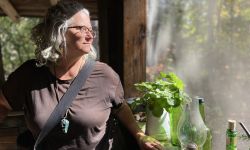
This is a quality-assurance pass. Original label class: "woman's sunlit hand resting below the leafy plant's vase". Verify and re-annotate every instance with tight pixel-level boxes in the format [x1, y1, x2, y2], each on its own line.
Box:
[137, 133, 163, 150]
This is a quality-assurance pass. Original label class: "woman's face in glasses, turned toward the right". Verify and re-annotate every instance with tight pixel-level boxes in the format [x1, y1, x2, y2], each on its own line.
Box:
[65, 11, 94, 55]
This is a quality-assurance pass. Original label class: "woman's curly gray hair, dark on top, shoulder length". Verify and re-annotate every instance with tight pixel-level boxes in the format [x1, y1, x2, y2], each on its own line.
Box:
[32, 0, 96, 66]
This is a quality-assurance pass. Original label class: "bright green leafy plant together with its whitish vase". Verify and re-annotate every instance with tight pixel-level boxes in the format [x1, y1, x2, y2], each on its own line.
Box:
[131, 72, 190, 140]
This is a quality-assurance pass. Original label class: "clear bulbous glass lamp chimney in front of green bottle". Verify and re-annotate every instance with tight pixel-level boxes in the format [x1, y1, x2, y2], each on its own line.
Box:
[177, 99, 207, 150]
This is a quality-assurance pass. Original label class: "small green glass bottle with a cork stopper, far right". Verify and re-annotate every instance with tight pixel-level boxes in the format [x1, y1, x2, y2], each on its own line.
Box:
[226, 120, 237, 150]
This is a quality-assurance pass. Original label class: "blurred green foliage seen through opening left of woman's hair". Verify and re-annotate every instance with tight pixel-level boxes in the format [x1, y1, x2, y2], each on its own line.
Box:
[0, 17, 39, 77]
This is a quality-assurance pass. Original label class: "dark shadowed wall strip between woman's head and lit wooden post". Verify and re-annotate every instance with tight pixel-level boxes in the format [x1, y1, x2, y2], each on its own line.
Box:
[98, 0, 124, 83]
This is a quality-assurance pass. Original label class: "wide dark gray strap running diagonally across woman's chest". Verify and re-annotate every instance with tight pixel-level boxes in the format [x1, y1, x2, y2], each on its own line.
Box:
[34, 59, 95, 150]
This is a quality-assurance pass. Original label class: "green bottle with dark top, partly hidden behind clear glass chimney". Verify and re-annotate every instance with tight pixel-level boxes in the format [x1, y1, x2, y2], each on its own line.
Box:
[197, 97, 212, 150]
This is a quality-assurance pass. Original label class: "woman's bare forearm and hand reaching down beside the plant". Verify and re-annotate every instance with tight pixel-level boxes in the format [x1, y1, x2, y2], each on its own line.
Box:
[115, 102, 162, 150]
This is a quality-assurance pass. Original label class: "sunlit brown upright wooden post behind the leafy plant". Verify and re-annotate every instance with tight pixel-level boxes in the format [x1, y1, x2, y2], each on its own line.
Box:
[123, 0, 147, 97]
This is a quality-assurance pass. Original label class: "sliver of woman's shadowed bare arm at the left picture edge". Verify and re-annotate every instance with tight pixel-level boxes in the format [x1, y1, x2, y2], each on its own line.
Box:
[0, 90, 12, 123]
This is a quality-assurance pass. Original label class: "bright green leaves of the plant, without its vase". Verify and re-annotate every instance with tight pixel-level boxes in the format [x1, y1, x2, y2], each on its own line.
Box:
[132, 72, 190, 117]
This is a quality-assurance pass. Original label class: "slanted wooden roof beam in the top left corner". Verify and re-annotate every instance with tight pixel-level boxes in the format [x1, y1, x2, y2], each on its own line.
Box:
[0, 0, 20, 22]
